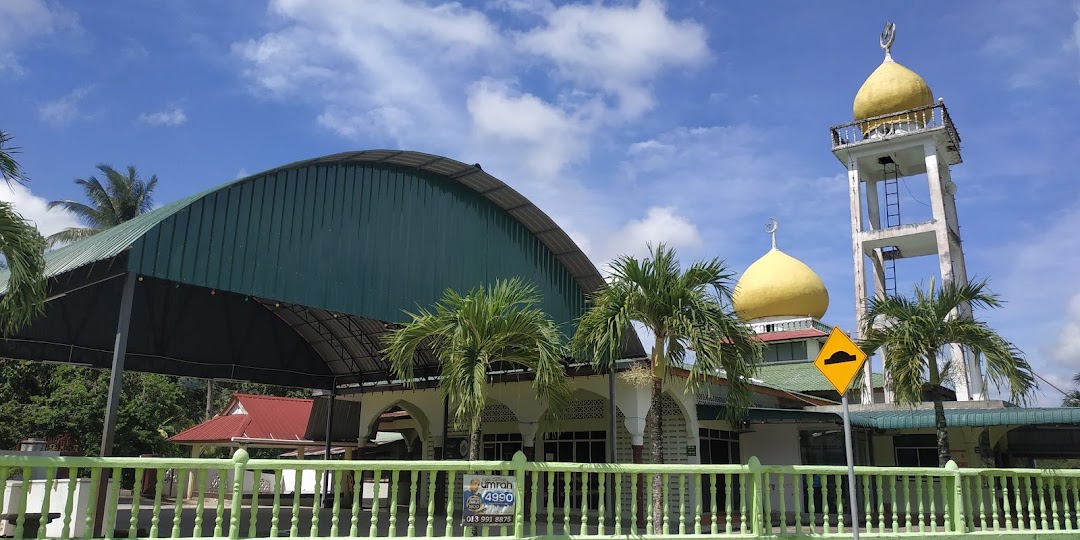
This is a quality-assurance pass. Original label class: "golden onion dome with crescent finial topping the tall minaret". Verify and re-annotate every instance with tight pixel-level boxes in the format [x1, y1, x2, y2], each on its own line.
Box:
[851, 23, 934, 132]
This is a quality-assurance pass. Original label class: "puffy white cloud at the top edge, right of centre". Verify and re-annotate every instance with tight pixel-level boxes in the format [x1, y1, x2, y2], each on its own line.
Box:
[518, 0, 708, 117]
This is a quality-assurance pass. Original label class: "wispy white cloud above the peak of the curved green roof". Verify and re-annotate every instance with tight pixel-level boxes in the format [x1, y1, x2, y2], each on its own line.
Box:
[233, 0, 501, 140]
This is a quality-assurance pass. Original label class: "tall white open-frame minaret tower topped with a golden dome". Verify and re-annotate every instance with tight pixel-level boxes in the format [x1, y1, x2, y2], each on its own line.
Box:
[829, 23, 984, 403]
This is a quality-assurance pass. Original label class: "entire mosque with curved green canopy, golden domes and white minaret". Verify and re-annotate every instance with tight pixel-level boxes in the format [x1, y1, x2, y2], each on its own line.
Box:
[0, 27, 1080, 490]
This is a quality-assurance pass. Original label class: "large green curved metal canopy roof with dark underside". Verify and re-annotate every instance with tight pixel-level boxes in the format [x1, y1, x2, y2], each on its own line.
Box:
[0, 150, 644, 387]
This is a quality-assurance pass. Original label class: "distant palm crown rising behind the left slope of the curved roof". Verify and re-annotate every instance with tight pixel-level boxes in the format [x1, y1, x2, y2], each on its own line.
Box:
[48, 163, 158, 245]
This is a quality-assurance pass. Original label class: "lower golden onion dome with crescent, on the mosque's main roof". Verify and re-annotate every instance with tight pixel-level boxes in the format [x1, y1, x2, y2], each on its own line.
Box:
[732, 220, 828, 321]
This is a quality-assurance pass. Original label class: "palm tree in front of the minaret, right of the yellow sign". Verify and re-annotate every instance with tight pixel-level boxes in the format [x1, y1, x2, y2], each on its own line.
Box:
[860, 280, 1037, 467]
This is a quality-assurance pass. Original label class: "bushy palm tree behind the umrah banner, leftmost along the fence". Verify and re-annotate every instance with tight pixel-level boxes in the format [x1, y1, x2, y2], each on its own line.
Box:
[382, 278, 573, 460]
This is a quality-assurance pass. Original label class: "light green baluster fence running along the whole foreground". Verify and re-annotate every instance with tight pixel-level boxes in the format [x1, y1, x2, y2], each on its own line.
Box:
[0, 450, 1080, 539]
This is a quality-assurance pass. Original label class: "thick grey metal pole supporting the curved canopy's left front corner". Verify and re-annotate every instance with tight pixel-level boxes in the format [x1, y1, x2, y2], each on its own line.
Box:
[94, 272, 135, 537]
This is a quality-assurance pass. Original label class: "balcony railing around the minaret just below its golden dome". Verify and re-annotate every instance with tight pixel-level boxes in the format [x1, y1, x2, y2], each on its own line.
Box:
[828, 99, 960, 150]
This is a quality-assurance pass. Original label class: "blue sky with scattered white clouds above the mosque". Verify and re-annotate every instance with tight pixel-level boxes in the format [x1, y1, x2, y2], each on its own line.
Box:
[0, 0, 1080, 404]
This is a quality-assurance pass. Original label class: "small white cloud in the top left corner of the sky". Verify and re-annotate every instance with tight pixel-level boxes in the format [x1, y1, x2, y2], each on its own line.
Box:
[0, 0, 79, 76]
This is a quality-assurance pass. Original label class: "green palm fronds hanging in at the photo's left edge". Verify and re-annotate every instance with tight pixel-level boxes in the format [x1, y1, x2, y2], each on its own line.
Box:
[0, 132, 45, 335]
